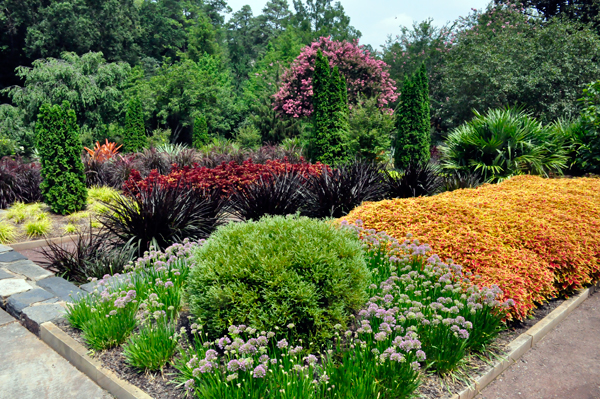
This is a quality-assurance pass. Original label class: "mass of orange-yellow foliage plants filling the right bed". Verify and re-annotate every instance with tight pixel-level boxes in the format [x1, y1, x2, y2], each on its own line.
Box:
[343, 176, 600, 318]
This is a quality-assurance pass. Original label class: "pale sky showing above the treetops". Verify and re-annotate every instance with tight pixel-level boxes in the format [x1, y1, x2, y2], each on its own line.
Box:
[227, 0, 490, 50]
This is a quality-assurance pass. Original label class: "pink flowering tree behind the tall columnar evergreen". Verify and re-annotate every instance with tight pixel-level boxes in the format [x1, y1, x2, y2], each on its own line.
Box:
[273, 37, 398, 118]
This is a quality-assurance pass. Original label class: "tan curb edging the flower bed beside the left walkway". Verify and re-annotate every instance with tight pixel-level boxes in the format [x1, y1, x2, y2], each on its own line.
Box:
[40, 321, 152, 399]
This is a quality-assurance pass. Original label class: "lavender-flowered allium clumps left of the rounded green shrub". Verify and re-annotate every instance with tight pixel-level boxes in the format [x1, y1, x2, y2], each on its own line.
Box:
[66, 240, 202, 350]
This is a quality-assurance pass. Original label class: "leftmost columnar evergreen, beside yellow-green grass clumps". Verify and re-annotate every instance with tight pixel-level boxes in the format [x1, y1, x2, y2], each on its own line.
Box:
[35, 101, 87, 215]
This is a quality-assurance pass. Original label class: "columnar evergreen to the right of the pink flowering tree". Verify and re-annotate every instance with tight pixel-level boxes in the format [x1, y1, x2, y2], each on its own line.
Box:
[394, 65, 431, 169]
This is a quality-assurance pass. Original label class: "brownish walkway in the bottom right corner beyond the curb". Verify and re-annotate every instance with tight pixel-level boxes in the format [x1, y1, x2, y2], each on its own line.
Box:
[476, 291, 600, 399]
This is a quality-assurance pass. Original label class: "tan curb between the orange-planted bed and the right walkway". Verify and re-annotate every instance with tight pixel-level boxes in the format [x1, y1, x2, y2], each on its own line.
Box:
[451, 282, 600, 399]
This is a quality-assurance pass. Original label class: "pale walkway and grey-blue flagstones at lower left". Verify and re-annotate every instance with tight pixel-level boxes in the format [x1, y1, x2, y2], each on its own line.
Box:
[0, 245, 112, 399]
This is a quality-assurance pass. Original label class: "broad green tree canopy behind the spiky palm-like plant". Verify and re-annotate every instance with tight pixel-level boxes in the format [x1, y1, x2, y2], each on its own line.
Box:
[432, 6, 600, 129]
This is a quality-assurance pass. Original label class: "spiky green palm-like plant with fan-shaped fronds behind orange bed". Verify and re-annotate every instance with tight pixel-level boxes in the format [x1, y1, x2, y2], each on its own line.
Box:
[440, 108, 568, 182]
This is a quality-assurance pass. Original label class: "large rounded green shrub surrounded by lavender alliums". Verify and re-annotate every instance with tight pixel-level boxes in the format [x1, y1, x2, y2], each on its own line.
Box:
[187, 216, 370, 346]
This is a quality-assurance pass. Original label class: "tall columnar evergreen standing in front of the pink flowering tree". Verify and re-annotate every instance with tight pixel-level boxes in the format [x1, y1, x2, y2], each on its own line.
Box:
[309, 51, 348, 165]
